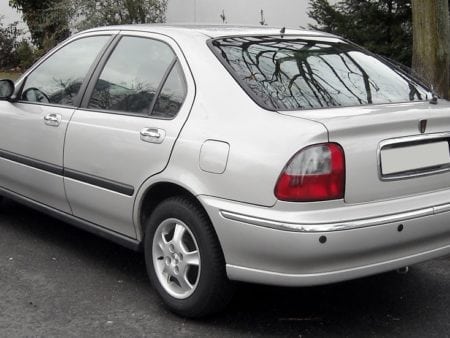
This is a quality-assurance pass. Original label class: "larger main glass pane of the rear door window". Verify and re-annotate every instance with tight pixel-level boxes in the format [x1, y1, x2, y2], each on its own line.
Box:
[88, 36, 175, 115]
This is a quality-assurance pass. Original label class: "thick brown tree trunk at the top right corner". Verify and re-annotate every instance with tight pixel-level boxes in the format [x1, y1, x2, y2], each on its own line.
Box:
[412, 0, 450, 99]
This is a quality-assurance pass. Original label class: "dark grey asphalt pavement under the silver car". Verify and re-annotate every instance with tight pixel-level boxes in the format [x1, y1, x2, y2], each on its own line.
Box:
[0, 200, 450, 337]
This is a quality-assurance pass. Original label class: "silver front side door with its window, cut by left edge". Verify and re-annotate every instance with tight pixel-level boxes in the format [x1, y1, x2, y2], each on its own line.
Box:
[0, 33, 111, 213]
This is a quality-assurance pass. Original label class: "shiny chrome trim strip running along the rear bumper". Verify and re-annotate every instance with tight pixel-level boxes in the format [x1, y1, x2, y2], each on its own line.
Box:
[219, 203, 450, 233]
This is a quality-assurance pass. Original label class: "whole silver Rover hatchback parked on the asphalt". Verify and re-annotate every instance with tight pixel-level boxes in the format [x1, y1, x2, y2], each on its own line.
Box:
[0, 25, 450, 317]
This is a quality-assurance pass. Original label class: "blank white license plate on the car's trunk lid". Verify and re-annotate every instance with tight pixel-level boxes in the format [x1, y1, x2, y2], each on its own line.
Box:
[381, 141, 450, 175]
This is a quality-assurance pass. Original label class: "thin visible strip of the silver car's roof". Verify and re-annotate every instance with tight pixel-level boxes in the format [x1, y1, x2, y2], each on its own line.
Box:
[81, 24, 336, 38]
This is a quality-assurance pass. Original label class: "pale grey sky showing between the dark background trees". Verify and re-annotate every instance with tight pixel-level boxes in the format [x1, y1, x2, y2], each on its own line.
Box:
[0, 0, 311, 28]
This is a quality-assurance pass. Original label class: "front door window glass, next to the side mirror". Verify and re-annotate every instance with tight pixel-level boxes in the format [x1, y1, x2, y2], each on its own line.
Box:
[21, 35, 110, 106]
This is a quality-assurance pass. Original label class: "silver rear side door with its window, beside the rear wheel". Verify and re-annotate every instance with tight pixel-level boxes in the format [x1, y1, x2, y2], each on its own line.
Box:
[64, 32, 194, 238]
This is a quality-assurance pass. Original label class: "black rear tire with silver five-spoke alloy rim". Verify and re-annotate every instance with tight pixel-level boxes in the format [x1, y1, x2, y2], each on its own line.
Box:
[144, 197, 233, 318]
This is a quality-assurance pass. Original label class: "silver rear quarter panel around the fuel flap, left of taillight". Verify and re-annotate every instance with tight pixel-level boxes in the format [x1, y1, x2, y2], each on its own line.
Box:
[135, 36, 328, 210]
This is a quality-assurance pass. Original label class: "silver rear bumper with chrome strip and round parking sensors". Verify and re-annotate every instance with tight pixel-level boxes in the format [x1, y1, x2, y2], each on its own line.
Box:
[200, 197, 450, 286]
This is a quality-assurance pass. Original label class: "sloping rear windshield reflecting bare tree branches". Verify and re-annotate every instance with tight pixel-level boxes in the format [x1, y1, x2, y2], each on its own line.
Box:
[209, 36, 431, 110]
